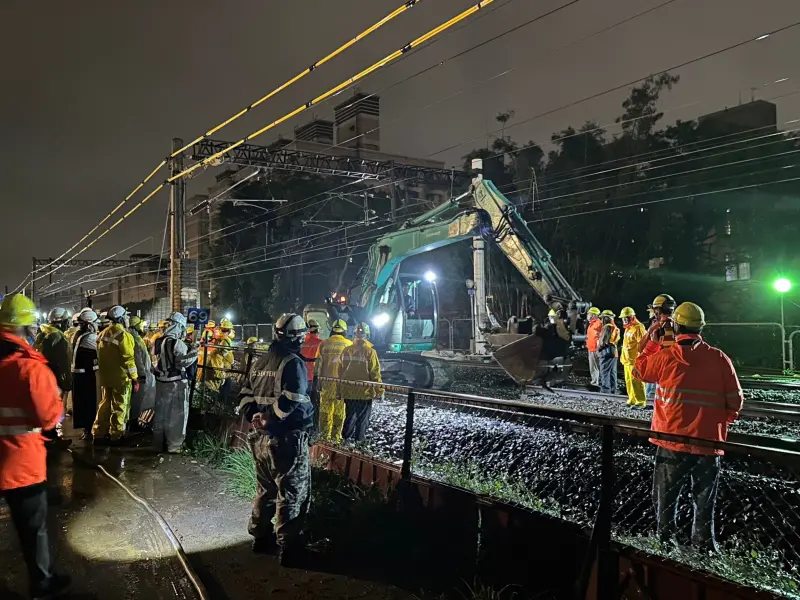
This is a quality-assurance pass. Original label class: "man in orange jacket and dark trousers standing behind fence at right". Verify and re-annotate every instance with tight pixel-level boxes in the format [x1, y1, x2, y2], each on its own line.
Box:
[634, 302, 743, 551]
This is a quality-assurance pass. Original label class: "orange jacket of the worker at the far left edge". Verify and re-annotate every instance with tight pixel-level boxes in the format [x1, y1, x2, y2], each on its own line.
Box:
[0, 332, 63, 490]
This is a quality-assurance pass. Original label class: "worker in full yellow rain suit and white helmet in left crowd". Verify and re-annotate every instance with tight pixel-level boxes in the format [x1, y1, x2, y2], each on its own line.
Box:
[92, 306, 139, 445]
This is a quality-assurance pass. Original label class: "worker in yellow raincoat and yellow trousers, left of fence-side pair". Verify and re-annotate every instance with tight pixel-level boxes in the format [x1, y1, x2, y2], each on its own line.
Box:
[314, 319, 353, 443]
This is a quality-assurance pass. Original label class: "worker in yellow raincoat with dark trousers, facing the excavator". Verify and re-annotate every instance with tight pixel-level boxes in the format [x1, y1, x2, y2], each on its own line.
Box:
[338, 323, 383, 442]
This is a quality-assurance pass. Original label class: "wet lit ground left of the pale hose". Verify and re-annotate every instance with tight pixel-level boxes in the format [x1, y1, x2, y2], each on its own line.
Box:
[0, 434, 197, 600]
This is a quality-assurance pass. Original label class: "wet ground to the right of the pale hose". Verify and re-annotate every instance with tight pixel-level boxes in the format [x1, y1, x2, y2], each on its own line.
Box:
[65, 432, 414, 600]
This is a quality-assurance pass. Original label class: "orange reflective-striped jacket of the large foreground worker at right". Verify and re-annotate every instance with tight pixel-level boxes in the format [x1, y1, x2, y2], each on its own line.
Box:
[633, 335, 743, 454]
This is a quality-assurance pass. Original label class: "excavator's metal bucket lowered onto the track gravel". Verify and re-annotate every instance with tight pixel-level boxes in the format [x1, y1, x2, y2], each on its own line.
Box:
[488, 333, 571, 385]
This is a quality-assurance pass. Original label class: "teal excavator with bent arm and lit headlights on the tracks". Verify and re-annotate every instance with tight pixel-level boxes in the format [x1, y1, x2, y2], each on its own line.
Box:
[310, 159, 591, 389]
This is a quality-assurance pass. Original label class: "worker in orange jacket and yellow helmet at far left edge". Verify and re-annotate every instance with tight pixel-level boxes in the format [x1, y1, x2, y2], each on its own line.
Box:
[0, 294, 69, 598]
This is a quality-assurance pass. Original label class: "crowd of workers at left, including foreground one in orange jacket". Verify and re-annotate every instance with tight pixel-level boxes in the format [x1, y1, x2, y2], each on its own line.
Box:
[0, 294, 205, 598]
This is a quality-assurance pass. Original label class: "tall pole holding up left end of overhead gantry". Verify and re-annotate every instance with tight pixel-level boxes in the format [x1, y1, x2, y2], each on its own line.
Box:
[169, 138, 197, 313]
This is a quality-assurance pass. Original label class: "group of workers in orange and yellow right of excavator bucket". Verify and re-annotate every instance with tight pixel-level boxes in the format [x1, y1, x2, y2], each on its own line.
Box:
[586, 294, 744, 551]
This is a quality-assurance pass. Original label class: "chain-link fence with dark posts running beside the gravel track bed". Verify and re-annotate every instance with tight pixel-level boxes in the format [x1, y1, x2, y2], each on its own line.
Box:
[181, 346, 800, 598]
